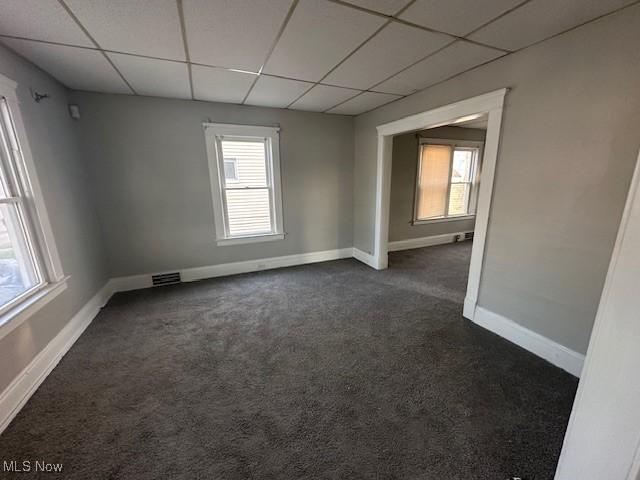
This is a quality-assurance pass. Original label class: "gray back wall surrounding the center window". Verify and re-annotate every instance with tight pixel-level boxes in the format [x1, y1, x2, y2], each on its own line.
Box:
[74, 92, 354, 276]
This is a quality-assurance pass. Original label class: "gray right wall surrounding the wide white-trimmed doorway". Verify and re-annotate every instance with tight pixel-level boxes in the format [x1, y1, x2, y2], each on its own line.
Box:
[354, 5, 640, 352]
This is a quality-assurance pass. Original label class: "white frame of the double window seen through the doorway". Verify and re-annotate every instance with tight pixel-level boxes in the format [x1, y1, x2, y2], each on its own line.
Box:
[411, 137, 484, 225]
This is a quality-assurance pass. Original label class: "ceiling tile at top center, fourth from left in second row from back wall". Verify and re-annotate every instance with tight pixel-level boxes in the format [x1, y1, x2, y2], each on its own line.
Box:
[264, 0, 386, 81]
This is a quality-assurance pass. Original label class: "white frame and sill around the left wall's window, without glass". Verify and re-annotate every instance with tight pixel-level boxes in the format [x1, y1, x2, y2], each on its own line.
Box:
[0, 74, 68, 338]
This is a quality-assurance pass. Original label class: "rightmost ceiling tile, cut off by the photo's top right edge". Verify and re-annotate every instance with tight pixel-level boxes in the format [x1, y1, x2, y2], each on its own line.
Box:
[469, 0, 633, 50]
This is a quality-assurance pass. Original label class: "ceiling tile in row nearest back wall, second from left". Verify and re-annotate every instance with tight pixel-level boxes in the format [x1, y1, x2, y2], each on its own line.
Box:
[107, 53, 191, 98]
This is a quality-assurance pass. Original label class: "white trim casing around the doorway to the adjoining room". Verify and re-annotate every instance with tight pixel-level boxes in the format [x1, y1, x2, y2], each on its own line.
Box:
[372, 88, 508, 320]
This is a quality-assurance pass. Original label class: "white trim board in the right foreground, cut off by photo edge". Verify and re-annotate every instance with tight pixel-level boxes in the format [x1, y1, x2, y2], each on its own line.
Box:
[555, 148, 640, 480]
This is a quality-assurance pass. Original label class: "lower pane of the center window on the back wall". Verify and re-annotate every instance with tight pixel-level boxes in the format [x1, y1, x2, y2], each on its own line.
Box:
[225, 188, 272, 236]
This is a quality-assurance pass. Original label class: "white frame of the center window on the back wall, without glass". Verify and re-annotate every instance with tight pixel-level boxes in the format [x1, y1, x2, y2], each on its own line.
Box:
[203, 123, 285, 246]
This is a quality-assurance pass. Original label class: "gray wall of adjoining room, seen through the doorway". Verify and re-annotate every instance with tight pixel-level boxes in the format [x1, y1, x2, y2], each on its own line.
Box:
[389, 127, 486, 242]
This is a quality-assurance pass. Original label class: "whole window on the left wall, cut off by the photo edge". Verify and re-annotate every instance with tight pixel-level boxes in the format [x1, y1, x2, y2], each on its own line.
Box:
[0, 75, 66, 338]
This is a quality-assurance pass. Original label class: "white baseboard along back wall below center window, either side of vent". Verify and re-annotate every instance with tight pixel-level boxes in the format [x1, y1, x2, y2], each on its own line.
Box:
[111, 247, 353, 292]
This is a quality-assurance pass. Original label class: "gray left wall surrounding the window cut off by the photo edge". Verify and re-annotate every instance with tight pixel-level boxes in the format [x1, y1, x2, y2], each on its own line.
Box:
[0, 46, 107, 391]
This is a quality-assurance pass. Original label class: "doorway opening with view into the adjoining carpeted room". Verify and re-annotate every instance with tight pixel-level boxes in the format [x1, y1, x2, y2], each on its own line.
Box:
[388, 114, 488, 305]
